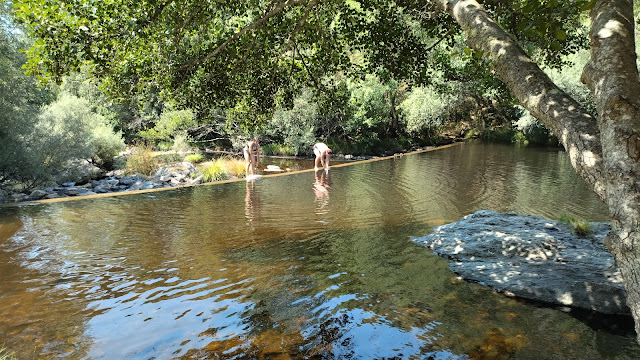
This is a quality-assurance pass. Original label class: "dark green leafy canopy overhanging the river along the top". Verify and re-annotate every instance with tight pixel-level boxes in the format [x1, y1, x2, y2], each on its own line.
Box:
[14, 0, 590, 126]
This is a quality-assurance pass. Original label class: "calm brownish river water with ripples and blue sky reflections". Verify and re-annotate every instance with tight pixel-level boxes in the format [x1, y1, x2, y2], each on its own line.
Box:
[0, 144, 640, 360]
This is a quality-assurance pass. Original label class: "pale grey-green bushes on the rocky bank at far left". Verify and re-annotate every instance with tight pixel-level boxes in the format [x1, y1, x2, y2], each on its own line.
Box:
[0, 3, 124, 189]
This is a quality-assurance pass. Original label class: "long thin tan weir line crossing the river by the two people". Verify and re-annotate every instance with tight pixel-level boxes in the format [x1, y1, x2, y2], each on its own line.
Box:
[25, 142, 464, 206]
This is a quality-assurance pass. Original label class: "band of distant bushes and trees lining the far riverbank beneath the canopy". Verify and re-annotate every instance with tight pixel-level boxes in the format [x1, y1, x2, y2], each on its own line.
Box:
[0, 4, 593, 188]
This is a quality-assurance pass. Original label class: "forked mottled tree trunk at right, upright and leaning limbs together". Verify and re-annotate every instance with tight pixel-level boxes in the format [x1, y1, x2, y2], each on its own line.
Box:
[436, 0, 640, 341]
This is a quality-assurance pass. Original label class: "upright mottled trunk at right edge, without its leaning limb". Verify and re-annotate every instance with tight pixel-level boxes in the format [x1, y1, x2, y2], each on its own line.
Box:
[582, 0, 640, 341]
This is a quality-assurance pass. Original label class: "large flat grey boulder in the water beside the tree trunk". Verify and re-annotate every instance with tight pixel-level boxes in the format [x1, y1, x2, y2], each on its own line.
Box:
[413, 210, 630, 314]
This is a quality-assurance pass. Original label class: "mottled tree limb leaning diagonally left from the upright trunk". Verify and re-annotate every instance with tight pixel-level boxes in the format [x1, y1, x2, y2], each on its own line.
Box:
[432, 0, 606, 199]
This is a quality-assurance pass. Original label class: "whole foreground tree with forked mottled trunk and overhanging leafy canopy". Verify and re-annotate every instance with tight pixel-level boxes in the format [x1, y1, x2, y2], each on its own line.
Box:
[15, 0, 640, 340]
